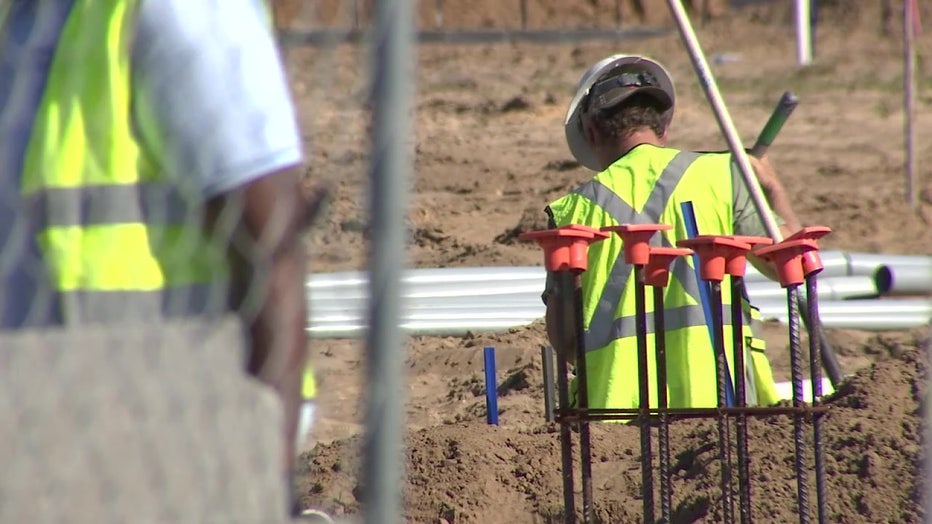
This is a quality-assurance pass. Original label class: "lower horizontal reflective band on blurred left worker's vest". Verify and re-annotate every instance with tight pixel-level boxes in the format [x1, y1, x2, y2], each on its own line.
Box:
[52, 284, 227, 325]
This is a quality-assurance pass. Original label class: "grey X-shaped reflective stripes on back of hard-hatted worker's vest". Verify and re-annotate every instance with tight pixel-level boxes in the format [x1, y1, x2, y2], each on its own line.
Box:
[575, 151, 705, 351]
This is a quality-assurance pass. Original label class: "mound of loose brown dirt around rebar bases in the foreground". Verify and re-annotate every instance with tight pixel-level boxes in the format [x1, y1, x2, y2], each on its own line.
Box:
[302, 333, 928, 523]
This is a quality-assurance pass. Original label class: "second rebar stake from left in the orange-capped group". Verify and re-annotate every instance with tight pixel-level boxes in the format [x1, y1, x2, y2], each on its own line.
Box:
[563, 272, 593, 524]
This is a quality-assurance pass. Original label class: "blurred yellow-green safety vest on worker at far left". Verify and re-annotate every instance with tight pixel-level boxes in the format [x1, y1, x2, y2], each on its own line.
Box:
[10, 0, 315, 398]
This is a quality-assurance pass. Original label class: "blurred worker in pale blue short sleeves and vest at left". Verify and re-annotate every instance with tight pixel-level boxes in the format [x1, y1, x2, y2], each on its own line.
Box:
[0, 0, 322, 516]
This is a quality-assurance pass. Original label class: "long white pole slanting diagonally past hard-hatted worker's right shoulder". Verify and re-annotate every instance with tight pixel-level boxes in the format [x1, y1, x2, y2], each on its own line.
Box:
[667, 0, 843, 387]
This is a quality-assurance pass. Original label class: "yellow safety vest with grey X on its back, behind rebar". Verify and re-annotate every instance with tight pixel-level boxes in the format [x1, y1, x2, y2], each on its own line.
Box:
[549, 144, 778, 408]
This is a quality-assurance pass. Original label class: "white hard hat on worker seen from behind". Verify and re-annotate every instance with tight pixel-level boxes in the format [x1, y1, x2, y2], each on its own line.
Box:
[563, 55, 676, 171]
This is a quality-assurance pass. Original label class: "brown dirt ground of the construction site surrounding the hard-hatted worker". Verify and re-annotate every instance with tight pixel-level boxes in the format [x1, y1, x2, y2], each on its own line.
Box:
[279, 0, 932, 524]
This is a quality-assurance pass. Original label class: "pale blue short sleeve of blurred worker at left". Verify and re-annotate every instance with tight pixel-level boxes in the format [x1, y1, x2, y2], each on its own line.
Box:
[132, 0, 302, 198]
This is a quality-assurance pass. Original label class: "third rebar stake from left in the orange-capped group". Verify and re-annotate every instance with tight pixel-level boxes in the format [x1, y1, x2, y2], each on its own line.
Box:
[634, 264, 656, 524]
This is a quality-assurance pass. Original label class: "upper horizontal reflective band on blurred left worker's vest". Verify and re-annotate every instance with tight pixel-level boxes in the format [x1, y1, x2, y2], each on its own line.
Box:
[27, 184, 200, 227]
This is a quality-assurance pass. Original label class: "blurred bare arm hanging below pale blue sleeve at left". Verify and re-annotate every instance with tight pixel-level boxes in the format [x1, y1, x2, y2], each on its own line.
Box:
[208, 169, 323, 471]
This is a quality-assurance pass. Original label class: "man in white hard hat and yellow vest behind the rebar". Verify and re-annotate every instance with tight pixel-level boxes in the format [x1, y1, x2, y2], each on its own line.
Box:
[543, 55, 799, 414]
